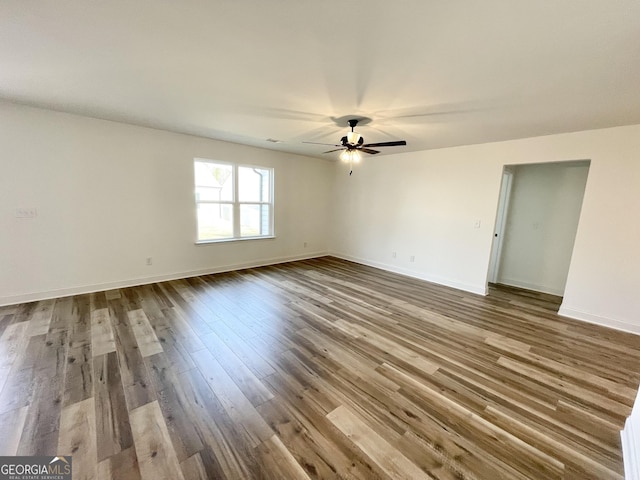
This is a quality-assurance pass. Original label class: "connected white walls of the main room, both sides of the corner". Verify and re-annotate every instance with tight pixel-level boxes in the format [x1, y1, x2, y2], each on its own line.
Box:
[0, 103, 640, 333]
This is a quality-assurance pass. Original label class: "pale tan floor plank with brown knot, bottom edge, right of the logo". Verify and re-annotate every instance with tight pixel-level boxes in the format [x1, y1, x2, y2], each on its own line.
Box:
[129, 401, 184, 480]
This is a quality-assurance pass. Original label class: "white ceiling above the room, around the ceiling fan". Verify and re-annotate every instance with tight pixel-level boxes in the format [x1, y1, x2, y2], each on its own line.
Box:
[0, 0, 640, 158]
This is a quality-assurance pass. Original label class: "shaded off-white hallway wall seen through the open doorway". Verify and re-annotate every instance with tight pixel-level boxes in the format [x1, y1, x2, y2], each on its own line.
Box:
[498, 162, 589, 295]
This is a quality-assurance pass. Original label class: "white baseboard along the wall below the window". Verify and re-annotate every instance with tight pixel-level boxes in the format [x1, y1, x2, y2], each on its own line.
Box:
[0, 251, 328, 306]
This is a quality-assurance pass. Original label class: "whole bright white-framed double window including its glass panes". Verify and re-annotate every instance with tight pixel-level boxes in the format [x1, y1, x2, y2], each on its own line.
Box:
[194, 159, 273, 242]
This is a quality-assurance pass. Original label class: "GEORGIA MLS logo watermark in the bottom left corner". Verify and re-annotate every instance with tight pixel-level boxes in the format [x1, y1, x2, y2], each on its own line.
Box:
[0, 456, 71, 480]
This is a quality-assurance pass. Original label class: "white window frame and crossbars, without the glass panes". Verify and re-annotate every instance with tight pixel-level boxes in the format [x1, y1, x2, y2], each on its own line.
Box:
[193, 157, 275, 245]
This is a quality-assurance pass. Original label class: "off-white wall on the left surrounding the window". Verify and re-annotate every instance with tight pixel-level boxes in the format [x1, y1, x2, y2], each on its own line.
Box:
[0, 103, 334, 305]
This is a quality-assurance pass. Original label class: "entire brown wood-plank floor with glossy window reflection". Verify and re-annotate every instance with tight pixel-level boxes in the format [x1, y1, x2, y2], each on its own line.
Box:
[0, 257, 640, 480]
